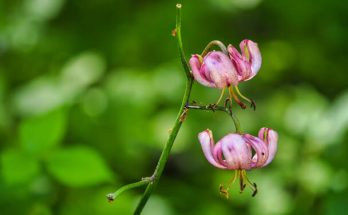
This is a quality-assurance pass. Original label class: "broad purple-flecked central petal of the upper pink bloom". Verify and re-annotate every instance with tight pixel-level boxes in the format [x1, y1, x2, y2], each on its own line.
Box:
[204, 51, 238, 88]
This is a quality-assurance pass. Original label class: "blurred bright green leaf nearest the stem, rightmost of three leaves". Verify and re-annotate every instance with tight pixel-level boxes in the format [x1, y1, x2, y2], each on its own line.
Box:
[47, 146, 111, 187]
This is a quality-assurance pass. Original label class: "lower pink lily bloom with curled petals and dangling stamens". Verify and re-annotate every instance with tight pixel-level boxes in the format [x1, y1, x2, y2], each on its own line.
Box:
[198, 128, 278, 198]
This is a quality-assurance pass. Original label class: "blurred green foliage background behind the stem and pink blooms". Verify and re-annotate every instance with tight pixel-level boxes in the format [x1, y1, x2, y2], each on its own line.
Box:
[0, 0, 348, 215]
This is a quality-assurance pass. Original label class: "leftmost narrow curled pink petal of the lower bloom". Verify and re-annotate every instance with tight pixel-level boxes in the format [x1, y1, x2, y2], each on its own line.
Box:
[198, 129, 226, 169]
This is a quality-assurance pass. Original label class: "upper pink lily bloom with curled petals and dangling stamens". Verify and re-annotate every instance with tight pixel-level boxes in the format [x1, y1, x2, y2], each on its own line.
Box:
[189, 40, 262, 109]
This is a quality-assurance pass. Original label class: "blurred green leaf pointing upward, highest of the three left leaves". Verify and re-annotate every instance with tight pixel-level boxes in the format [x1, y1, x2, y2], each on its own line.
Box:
[19, 109, 66, 154]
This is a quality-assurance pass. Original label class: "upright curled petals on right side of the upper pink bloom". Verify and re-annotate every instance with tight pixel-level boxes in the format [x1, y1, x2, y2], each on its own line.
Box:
[227, 40, 262, 82]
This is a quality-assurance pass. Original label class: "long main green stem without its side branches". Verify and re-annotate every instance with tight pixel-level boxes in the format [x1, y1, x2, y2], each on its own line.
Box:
[134, 4, 193, 215]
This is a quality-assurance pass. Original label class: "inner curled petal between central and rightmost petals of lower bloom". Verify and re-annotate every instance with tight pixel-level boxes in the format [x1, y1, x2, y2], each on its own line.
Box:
[243, 134, 269, 168]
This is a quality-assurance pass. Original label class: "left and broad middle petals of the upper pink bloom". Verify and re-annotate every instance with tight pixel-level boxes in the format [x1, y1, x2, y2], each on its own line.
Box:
[189, 51, 238, 88]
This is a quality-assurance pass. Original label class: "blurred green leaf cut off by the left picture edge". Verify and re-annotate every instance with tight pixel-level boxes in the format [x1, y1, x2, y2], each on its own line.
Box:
[1, 149, 40, 185]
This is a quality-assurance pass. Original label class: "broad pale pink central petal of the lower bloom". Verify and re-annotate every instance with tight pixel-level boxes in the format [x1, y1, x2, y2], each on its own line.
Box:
[218, 134, 252, 169]
